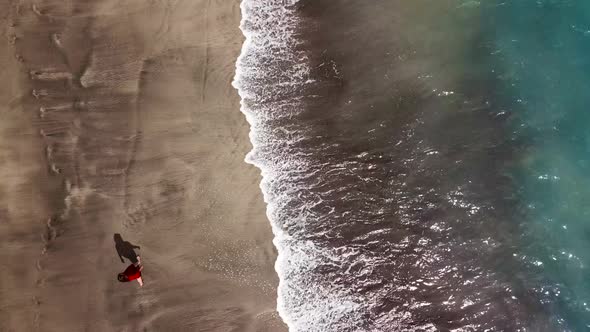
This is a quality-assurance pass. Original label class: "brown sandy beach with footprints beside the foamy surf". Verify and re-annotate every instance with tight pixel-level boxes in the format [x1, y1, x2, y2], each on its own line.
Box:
[0, 0, 286, 331]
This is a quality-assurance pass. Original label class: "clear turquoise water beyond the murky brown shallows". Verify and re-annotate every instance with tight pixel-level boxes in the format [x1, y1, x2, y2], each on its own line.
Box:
[490, 0, 590, 331]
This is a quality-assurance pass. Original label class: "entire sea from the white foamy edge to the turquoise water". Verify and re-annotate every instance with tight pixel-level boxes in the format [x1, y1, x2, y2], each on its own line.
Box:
[234, 0, 590, 331]
